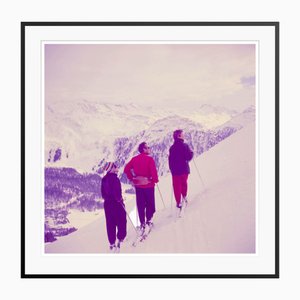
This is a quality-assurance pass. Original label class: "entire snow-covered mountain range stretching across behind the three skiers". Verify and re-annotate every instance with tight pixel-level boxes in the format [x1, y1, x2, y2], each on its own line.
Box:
[45, 100, 251, 174]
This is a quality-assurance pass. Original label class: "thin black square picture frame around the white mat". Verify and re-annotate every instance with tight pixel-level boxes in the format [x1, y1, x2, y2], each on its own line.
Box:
[20, 22, 280, 278]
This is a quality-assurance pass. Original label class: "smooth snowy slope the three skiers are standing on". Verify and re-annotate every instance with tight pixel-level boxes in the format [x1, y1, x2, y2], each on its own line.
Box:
[45, 123, 256, 253]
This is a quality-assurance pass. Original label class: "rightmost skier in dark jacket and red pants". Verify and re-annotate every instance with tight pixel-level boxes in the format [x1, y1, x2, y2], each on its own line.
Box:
[169, 129, 194, 209]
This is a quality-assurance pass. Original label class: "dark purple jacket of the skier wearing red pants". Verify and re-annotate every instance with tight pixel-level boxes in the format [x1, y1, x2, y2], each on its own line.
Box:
[169, 139, 194, 175]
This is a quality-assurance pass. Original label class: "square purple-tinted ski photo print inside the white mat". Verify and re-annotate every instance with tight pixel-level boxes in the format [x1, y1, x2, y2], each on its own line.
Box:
[42, 41, 258, 256]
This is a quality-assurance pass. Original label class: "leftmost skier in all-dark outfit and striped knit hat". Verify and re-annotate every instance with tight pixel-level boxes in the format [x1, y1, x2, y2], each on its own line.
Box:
[101, 162, 127, 252]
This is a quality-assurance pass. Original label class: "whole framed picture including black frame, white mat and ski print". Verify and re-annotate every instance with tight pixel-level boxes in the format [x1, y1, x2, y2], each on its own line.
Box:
[21, 22, 279, 278]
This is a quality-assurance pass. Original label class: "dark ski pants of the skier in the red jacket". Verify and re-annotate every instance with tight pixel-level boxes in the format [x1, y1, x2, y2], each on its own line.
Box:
[135, 187, 155, 224]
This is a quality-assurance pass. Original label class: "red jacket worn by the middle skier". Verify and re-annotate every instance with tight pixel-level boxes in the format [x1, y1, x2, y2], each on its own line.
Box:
[124, 153, 158, 188]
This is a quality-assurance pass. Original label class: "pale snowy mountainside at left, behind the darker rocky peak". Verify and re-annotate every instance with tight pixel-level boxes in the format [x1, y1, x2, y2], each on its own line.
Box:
[45, 100, 158, 171]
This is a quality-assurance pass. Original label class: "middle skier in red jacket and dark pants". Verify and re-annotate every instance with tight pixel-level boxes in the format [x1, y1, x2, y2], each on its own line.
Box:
[124, 142, 158, 232]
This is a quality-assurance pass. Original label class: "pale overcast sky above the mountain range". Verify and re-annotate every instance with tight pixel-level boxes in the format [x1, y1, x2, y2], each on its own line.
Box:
[45, 44, 255, 110]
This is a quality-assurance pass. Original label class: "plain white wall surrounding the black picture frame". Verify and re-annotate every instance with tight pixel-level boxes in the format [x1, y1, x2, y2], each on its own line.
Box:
[0, 0, 300, 300]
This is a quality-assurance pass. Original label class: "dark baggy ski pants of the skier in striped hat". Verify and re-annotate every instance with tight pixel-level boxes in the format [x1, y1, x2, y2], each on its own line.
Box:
[104, 201, 127, 245]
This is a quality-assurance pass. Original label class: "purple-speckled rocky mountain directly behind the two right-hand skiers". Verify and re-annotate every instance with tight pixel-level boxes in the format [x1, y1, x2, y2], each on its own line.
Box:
[112, 116, 237, 182]
